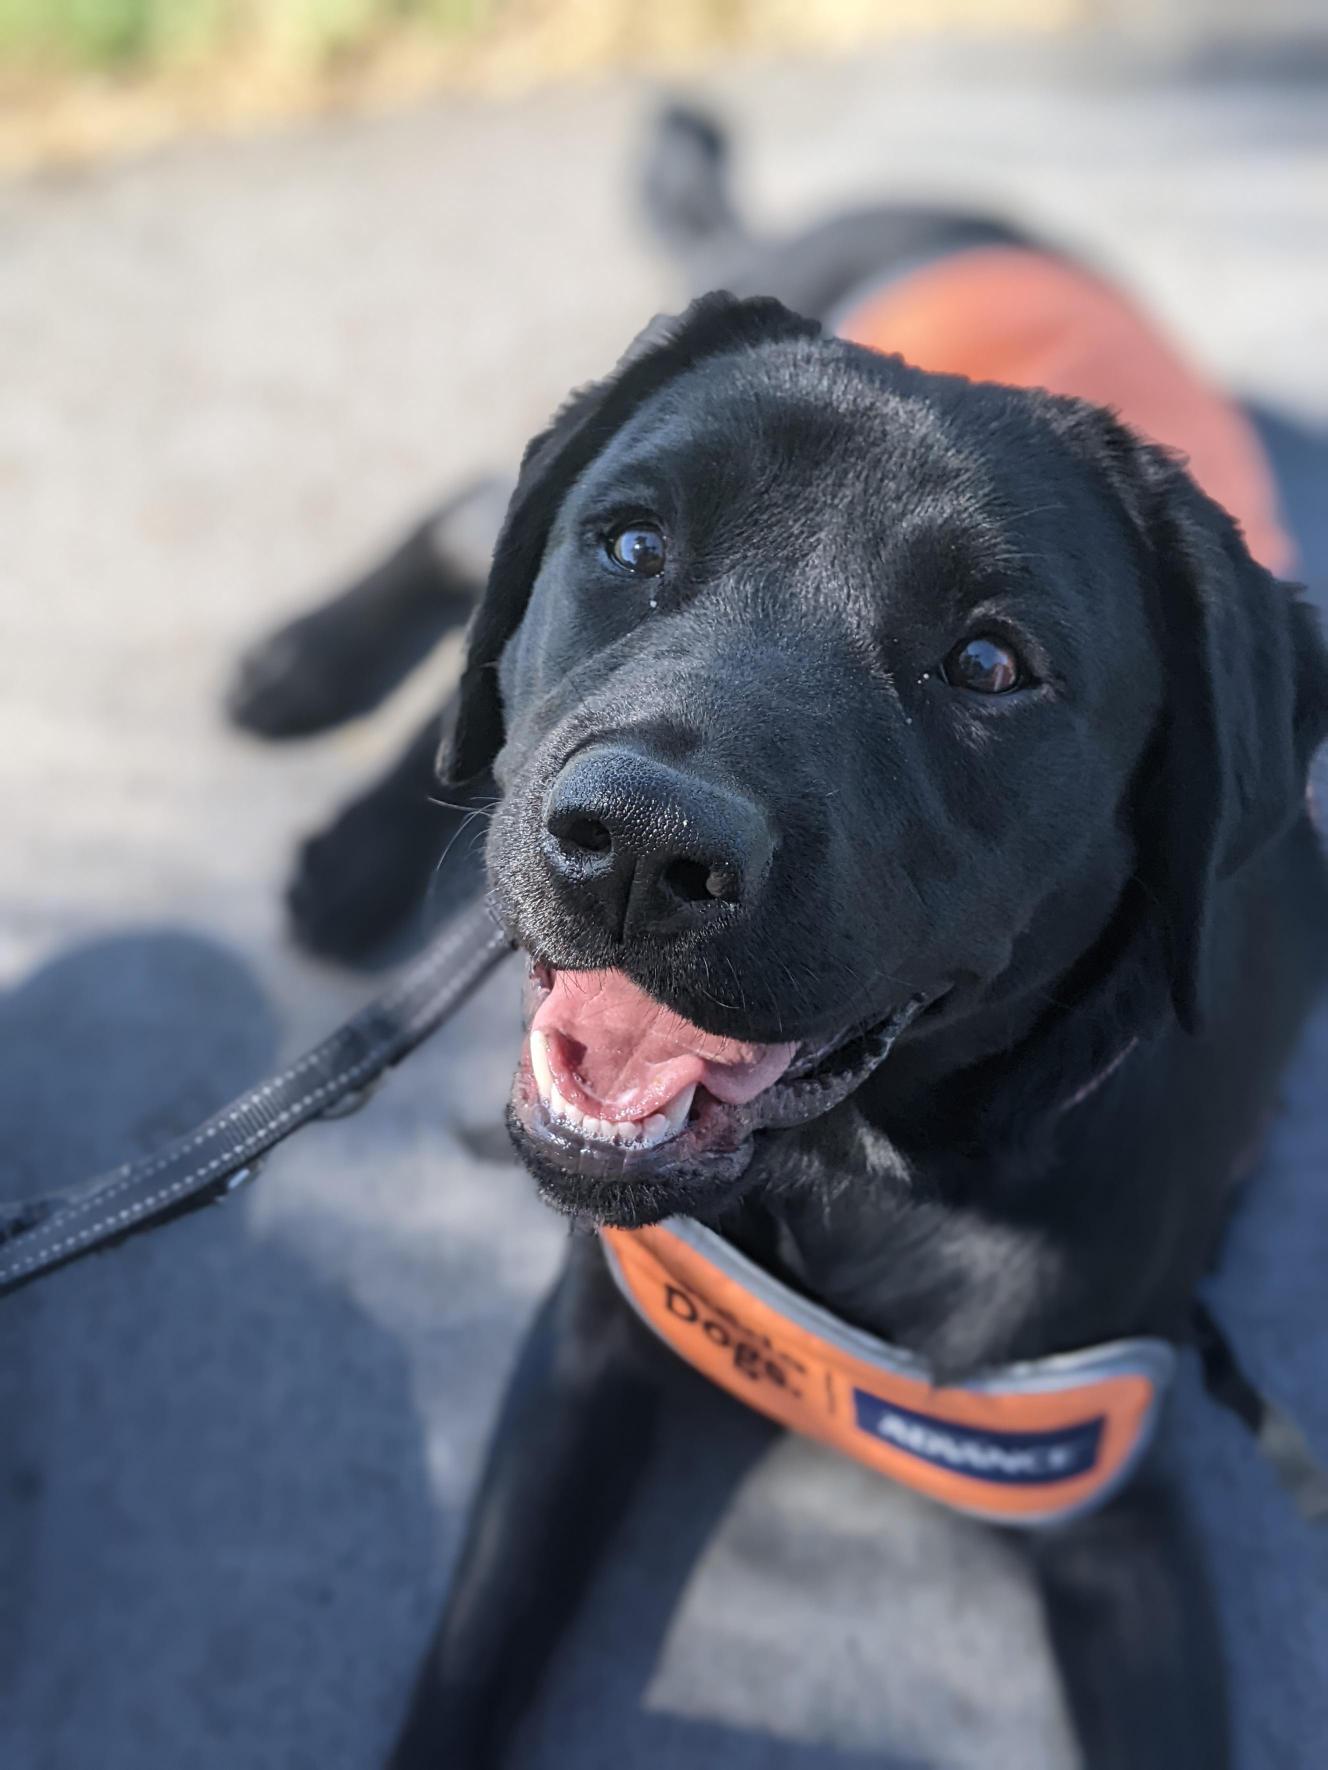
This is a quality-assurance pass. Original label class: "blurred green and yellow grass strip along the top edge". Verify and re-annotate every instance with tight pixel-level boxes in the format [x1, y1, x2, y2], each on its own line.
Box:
[0, 0, 1083, 173]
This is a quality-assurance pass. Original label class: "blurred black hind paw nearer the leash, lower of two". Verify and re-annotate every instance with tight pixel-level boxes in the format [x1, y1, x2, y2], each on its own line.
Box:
[287, 696, 498, 959]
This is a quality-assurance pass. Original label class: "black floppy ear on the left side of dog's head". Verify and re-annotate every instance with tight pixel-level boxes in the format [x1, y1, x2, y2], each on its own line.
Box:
[439, 294, 820, 782]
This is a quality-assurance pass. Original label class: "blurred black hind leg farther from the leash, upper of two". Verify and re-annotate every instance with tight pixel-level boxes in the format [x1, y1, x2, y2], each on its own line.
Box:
[227, 480, 510, 738]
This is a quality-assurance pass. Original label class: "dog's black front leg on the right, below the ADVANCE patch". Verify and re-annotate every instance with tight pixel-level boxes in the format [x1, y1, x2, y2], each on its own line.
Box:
[1029, 1473, 1231, 1770]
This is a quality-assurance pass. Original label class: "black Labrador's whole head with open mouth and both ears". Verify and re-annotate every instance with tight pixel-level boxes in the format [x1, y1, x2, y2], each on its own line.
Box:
[446, 296, 1328, 1225]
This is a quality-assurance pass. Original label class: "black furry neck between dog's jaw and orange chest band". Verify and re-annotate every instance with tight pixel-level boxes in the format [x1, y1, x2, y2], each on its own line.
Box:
[721, 877, 1172, 1377]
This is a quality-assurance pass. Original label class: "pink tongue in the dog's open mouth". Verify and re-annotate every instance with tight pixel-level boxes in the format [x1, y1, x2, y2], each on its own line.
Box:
[531, 972, 797, 1120]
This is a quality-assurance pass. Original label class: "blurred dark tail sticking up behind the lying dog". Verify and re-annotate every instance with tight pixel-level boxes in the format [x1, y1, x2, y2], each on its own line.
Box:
[639, 104, 747, 269]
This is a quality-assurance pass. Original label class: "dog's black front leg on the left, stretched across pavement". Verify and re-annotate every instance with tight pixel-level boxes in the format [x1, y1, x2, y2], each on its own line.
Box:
[391, 1235, 662, 1770]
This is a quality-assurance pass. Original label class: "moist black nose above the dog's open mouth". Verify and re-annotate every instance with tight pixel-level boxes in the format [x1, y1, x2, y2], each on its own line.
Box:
[544, 743, 774, 940]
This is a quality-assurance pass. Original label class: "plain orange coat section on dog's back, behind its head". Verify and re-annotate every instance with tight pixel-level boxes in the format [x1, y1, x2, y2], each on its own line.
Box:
[834, 246, 1296, 573]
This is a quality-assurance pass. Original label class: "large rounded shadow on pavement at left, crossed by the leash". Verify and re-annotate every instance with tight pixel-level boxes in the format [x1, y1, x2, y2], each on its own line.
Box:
[0, 929, 437, 1770]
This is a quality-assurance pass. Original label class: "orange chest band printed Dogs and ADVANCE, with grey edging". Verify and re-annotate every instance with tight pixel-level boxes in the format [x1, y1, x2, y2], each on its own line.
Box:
[600, 1218, 1176, 1526]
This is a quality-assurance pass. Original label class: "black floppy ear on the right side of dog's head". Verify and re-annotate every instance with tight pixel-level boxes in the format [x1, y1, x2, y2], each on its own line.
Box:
[1135, 444, 1328, 1032]
